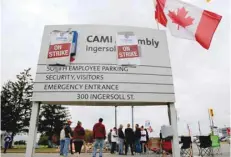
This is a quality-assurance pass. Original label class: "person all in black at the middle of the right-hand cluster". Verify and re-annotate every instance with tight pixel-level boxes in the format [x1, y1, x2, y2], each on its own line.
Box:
[125, 124, 134, 155]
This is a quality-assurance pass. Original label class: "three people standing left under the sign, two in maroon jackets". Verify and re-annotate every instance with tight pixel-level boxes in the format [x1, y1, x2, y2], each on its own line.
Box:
[60, 118, 106, 157]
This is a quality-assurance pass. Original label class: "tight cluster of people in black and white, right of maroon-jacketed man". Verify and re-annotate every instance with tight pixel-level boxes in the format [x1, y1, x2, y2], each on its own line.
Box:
[108, 124, 149, 155]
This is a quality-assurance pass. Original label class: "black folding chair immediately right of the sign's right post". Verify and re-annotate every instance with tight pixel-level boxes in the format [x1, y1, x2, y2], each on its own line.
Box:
[180, 136, 193, 157]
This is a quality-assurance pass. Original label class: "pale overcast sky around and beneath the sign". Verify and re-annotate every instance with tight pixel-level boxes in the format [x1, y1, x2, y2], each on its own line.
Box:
[1, 0, 231, 135]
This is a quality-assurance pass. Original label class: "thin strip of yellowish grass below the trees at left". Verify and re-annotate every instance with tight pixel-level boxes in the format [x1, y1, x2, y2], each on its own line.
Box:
[1, 148, 59, 153]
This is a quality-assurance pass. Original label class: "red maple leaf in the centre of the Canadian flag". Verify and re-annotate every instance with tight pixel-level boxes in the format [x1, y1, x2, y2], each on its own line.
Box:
[168, 7, 194, 30]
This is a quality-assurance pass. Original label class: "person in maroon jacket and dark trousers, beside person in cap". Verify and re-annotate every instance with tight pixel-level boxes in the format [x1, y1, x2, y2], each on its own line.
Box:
[73, 121, 85, 157]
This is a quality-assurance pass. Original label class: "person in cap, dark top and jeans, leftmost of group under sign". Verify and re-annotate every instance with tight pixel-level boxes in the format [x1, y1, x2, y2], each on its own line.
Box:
[63, 120, 72, 157]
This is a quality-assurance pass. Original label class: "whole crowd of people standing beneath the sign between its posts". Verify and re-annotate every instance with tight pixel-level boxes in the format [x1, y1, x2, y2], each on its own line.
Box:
[60, 118, 149, 157]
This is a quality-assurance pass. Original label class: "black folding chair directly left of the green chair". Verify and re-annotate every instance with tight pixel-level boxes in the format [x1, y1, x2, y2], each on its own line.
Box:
[198, 136, 212, 157]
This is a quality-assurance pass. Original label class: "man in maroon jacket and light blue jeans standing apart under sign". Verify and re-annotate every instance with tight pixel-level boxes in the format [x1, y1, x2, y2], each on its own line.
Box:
[92, 118, 106, 157]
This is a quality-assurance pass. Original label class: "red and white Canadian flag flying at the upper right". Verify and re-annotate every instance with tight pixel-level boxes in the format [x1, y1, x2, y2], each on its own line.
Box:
[155, 0, 222, 49]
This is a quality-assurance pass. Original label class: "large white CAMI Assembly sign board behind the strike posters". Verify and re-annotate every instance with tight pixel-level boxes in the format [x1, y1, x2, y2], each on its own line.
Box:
[32, 25, 175, 105]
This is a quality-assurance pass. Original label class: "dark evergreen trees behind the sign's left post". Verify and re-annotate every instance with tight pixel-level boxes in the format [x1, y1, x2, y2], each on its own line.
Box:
[1, 68, 93, 147]
